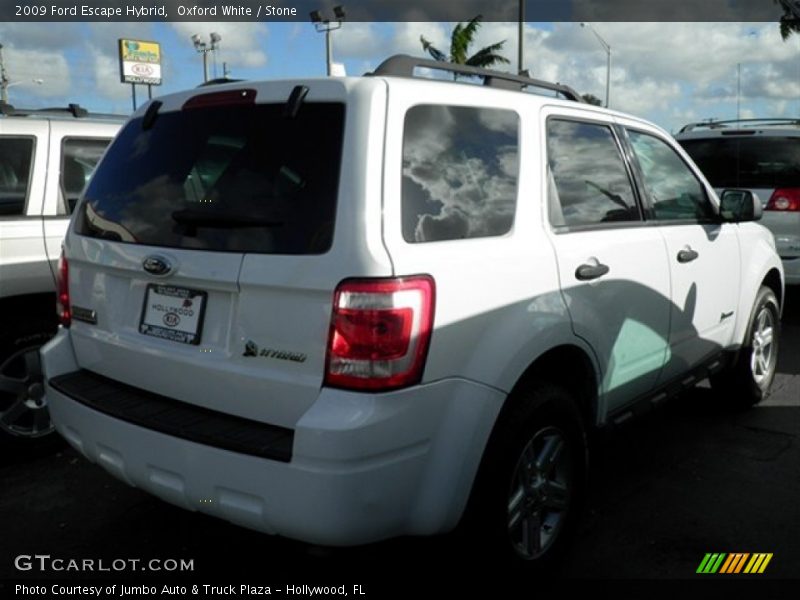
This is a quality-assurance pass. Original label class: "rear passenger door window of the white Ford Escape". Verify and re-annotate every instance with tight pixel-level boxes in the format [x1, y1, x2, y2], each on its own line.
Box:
[547, 119, 641, 227]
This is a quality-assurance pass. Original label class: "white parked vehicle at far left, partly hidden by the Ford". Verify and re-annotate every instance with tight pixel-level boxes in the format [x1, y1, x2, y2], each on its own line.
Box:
[0, 104, 124, 449]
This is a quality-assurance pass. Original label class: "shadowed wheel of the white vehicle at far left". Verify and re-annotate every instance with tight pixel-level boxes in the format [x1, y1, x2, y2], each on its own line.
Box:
[0, 319, 61, 452]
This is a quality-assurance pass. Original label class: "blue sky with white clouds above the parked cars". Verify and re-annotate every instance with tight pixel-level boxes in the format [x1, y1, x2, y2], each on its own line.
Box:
[0, 22, 800, 132]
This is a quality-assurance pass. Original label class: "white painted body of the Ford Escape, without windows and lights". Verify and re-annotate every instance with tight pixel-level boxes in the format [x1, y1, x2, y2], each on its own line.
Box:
[43, 59, 782, 545]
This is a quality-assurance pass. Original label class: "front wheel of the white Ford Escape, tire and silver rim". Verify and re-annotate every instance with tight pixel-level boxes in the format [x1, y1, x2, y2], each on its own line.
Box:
[710, 286, 781, 408]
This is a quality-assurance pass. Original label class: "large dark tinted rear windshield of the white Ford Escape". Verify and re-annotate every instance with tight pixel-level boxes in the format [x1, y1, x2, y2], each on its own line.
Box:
[77, 103, 345, 254]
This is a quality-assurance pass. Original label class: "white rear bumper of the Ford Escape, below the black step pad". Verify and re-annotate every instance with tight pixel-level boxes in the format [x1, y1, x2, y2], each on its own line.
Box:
[42, 330, 504, 545]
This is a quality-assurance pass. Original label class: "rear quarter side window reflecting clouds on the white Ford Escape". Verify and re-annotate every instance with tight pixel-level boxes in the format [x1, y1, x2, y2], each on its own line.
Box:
[402, 104, 519, 242]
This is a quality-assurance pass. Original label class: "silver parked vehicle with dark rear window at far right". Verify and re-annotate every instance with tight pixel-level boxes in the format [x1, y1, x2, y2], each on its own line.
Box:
[675, 119, 800, 285]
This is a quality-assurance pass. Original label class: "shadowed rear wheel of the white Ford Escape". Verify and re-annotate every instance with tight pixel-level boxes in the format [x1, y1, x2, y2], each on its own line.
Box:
[465, 383, 588, 573]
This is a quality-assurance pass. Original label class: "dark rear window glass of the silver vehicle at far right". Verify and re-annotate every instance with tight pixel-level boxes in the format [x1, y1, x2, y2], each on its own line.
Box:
[680, 136, 800, 188]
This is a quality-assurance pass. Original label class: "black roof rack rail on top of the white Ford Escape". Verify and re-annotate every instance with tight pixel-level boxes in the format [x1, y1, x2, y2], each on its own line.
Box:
[367, 54, 583, 102]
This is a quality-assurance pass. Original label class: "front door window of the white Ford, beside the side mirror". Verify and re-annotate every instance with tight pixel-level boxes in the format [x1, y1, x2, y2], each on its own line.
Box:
[628, 130, 714, 221]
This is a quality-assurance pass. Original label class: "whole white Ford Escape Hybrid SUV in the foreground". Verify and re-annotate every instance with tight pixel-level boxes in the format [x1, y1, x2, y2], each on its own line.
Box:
[43, 57, 783, 565]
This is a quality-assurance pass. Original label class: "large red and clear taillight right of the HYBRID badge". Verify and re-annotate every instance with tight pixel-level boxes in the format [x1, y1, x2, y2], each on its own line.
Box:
[325, 275, 435, 391]
